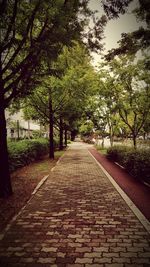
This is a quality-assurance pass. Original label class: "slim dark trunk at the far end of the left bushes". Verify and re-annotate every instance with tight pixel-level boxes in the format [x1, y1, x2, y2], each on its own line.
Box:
[49, 94, 54, 159]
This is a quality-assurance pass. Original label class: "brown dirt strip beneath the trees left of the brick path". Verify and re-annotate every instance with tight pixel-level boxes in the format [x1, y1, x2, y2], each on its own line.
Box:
[0, 151, 62, 232]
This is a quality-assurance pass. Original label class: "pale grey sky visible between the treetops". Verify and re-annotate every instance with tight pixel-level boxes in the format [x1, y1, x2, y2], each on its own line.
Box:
[89, 0, 145, 65]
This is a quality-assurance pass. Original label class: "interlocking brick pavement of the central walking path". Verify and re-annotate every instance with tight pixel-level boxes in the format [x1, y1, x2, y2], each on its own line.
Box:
[0, 143, 150, 267]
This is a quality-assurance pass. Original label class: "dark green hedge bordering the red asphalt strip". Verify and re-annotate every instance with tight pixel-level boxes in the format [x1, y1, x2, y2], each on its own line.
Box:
[107, 146, 150, 184]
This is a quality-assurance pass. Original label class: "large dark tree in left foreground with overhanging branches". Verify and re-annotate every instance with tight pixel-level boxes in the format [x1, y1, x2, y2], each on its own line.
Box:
[0, 0, 106, 197]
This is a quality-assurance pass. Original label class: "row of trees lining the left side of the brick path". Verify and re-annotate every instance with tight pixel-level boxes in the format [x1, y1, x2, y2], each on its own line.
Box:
[0, 0, 149, 197]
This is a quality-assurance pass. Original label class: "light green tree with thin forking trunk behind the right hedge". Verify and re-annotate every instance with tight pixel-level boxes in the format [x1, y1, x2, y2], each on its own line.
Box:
[104, 55, 150, 148]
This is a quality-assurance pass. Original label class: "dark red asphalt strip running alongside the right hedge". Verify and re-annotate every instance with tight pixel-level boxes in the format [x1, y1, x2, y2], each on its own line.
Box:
[89, 148, 150, 221]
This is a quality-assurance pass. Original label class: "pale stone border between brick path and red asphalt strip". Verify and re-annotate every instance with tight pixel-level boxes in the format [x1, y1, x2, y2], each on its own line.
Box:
[88, 150, 150, 234]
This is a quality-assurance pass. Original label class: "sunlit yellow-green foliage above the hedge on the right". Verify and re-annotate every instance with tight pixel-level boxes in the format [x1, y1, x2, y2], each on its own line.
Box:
[100, 55, 150, 147]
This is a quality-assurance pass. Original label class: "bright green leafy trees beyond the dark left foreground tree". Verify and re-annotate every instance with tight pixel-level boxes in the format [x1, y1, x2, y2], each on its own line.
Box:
[23, 42, 94, 158]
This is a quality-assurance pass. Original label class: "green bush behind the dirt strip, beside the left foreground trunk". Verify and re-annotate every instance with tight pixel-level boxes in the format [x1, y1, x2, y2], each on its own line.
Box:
[8, 138, 49, 172]
